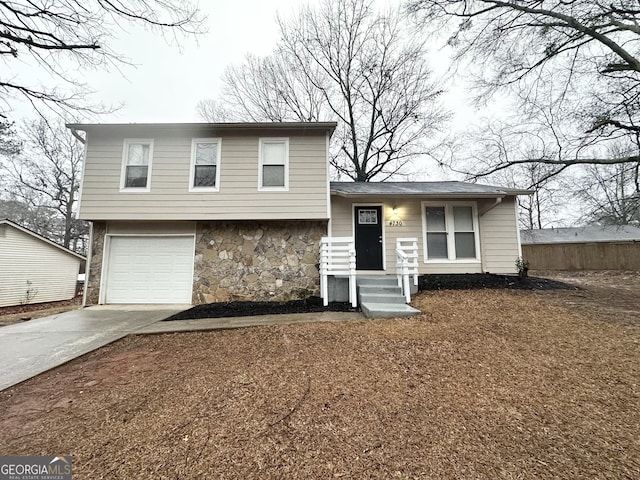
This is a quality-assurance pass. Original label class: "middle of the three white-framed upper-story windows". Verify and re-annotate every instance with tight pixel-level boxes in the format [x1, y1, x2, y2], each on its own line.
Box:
[189, 138, 222, 192]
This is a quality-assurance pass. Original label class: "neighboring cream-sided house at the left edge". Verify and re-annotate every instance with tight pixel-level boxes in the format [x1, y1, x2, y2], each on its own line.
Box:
[0, 220, 85, 307]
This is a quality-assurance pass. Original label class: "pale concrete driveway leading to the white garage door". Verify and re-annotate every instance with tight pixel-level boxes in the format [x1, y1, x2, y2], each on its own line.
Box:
[0, 305, 191, 390]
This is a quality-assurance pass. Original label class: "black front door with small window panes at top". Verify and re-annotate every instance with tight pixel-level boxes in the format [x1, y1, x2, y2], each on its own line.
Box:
[353, 206, 382, 270]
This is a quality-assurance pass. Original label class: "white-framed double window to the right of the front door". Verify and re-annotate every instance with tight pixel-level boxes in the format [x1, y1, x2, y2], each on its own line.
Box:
[422, 202, 480, 262]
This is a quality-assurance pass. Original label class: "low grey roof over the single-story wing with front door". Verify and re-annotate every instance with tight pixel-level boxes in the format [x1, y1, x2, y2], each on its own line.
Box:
[331, 182, 533, 198]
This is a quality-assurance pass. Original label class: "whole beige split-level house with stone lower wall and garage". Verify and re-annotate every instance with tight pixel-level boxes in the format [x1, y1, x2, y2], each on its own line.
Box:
[68, 122, 529, 312]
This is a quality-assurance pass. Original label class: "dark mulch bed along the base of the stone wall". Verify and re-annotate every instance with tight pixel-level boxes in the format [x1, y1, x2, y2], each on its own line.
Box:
[163, 297, 359, 322]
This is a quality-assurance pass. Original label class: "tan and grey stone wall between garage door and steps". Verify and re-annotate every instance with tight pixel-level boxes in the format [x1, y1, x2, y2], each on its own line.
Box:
[193, 221, 327, 304]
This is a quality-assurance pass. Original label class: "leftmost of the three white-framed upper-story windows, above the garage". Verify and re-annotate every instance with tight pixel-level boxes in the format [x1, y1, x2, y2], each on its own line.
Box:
[120, 138, 153, 192]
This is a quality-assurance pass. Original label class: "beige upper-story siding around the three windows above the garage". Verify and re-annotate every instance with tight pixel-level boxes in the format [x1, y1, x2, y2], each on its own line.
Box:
[79, 130, 329, 220]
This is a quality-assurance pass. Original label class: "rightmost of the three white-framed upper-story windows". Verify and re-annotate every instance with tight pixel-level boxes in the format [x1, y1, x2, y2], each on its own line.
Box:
[258, 138, 289, 191]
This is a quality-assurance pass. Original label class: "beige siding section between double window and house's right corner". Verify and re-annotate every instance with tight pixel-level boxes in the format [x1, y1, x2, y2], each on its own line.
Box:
[478, 197, 519, 273]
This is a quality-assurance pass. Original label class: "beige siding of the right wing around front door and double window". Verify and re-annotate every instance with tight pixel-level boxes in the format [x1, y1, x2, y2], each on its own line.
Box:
[330, 195, 518, 274]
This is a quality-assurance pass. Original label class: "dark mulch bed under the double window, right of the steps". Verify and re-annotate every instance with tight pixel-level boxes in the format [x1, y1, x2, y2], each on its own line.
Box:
[420, 273, 579, 290]
